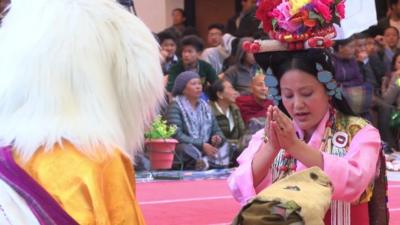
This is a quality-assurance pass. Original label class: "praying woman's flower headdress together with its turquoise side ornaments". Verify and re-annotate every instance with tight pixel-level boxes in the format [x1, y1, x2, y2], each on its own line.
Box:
[243, 0, 345, 104]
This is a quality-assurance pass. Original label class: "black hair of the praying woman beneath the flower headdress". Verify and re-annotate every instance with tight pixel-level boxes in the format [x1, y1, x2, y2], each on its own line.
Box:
[255, 49, 355, 115]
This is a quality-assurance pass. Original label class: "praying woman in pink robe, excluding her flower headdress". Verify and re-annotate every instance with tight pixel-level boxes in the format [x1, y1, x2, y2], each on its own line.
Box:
[228, 50, 384, 225]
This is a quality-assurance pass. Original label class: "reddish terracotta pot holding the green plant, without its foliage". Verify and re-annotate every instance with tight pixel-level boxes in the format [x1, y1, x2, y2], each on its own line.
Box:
[145, 139, 178, 170]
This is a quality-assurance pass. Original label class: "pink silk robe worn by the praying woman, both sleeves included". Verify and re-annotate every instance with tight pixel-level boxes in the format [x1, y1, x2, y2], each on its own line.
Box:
[228, 113, 381, 225]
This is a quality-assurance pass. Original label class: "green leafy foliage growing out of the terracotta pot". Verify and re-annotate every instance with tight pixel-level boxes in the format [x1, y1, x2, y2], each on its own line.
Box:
[144, 116, 176, 139]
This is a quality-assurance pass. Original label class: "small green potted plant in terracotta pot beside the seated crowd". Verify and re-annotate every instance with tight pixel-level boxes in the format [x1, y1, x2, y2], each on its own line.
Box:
[144, 116, 178, 169]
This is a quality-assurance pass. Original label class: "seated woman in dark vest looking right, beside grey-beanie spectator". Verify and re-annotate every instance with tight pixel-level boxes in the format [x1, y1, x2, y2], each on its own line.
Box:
[209, 80, 246, 162]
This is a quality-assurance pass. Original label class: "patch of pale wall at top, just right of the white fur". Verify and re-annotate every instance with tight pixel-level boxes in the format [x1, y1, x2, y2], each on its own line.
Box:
[134, 0, 184, 32]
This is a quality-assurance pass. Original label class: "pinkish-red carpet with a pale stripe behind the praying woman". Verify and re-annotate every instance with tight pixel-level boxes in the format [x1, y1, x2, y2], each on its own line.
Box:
[137, 180, 400, 225]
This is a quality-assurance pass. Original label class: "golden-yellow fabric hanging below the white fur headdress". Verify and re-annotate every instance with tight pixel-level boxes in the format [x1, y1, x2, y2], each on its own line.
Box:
[15, 143, 145, 225]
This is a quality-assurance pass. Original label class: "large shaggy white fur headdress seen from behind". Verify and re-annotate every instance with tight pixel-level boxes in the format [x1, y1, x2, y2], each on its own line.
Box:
[0, 0, 163, 160]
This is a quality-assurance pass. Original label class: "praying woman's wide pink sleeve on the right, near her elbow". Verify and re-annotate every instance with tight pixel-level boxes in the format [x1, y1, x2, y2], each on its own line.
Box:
[323, 125, 381, 201]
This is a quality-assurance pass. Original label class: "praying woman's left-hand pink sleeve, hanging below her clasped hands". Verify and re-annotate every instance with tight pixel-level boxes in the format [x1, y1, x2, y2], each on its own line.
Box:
[228, 130, 272, 205]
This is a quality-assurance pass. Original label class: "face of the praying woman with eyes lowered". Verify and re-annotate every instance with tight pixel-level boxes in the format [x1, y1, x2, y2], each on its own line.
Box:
[280, 69, 329, 134]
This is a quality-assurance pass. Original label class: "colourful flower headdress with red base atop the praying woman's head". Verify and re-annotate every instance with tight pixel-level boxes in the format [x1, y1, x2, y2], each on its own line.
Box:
[244, 0, 345, 52]
